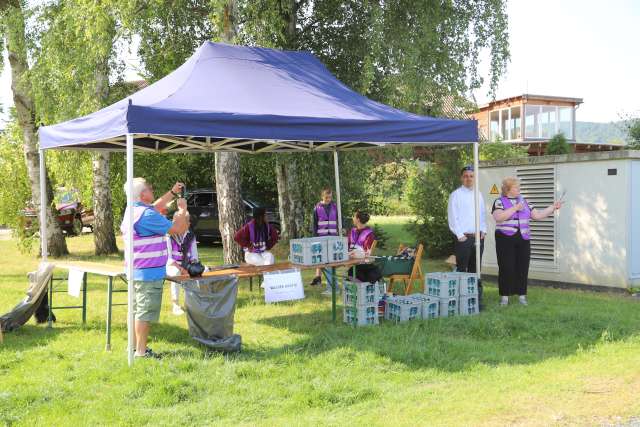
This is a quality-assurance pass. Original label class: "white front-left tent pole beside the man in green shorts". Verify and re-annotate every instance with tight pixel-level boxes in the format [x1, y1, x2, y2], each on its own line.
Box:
[125, 133, 135, 366]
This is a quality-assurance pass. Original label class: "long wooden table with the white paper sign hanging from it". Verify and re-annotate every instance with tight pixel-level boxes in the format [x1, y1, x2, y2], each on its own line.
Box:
[167, 258, 373, 322]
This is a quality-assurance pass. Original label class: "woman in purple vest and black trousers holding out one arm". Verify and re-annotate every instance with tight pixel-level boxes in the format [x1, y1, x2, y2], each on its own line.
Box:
[492, 177, 562, 305]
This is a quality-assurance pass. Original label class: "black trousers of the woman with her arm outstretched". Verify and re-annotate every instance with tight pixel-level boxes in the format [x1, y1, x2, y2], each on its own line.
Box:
[496, 231, 531, 296]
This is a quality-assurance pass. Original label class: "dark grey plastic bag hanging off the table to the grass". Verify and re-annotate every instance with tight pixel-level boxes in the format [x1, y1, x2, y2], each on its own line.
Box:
[181, 276, 241, 352]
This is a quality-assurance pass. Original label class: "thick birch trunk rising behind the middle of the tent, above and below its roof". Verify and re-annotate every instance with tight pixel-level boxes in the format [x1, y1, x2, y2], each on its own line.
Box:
[215, 0, 244, 264]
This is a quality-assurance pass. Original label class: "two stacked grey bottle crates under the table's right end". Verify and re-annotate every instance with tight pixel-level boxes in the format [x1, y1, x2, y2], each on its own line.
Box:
[343, 280, 380, 326]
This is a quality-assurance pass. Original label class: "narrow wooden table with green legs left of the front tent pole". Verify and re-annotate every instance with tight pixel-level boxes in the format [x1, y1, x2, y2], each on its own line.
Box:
[48, 261, 127, 351]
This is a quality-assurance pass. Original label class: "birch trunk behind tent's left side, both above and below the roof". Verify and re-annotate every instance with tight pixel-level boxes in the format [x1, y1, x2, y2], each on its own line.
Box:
[93, 59, 118, 255]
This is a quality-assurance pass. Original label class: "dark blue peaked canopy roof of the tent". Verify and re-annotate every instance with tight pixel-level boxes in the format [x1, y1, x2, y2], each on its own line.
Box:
[39, 42, 478, 152]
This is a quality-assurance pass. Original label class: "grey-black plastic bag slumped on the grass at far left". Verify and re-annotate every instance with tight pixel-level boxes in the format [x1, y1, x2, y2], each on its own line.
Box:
[0, 263, 55, 331]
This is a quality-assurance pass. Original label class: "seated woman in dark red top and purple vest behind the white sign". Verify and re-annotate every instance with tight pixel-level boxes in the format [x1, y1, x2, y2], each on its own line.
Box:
[234, 207, 278, 265]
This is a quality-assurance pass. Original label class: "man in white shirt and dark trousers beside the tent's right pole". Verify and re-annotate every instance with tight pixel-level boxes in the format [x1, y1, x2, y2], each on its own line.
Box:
[447, 165, 487, 305]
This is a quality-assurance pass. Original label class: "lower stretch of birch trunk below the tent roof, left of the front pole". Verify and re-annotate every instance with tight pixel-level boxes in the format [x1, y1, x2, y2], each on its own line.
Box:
[93, 152, 118, 255]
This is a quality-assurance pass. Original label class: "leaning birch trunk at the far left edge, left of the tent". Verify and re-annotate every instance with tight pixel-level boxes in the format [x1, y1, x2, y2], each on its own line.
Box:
[4, 0, 69, 257]
